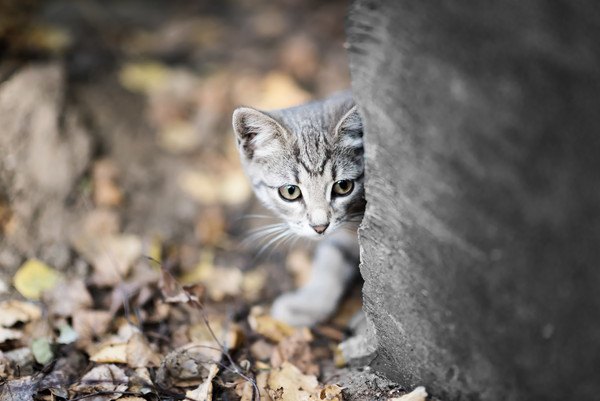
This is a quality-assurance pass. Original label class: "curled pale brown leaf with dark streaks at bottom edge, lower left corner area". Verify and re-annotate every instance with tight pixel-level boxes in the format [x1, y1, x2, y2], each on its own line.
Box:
[73, 365, 129, 401]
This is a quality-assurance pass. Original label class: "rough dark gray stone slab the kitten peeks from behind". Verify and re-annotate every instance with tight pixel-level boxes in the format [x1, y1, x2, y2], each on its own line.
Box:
[348, 0, 600, 400]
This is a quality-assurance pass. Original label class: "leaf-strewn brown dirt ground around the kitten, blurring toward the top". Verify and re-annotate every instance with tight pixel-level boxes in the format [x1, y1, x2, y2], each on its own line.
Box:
[0, 0, 410, 401]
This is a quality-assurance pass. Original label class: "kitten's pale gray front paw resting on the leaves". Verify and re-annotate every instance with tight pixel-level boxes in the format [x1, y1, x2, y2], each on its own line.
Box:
[271, 289, 337, 327]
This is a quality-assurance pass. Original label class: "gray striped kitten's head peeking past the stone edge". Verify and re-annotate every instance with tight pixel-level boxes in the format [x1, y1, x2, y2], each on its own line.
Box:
[233, 92, 365, 238]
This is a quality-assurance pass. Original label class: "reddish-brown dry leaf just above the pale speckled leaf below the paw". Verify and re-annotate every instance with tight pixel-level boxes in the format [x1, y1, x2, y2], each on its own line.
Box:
[271, 328, 319, 376]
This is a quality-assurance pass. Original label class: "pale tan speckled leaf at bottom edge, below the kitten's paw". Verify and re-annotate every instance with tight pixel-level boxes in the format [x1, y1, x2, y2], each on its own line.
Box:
[267, 362, 319, 401]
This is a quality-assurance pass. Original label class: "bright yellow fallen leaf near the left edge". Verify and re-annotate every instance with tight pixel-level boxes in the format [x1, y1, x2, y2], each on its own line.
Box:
[13, 259, 62, 301]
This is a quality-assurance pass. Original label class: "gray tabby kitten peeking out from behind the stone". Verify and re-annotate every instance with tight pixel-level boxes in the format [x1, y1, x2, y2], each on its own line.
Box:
[233, 92, 365, 326]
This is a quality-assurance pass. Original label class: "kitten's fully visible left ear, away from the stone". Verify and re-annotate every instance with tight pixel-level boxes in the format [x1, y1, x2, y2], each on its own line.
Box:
[233, 107, 285, 160]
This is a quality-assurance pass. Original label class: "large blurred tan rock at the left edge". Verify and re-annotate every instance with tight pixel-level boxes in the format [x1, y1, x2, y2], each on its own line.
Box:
[0, 63, 91, 268]
